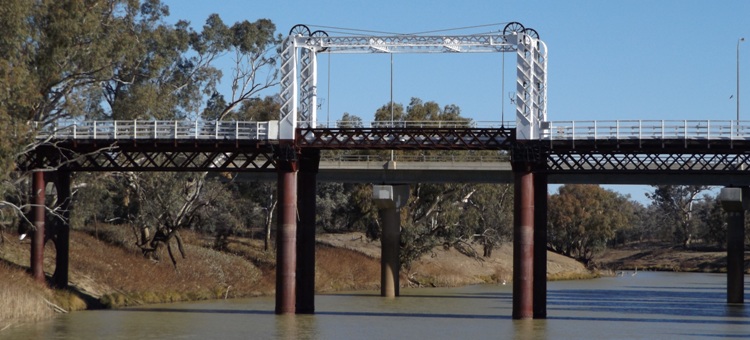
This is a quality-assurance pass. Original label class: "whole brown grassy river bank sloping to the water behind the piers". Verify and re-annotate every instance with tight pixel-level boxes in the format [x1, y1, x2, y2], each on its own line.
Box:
[0, 225, 580, 329]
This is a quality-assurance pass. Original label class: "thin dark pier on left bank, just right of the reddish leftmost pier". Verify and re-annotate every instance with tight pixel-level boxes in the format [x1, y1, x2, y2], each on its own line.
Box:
[50, 171, 71, 288]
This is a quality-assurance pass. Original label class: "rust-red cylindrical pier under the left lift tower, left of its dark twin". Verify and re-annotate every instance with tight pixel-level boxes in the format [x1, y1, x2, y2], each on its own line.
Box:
[276, 147, 297, 314]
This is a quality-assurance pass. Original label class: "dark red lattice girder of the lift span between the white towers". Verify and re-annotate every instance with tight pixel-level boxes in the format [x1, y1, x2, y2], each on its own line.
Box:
[297, 128, 515, 150]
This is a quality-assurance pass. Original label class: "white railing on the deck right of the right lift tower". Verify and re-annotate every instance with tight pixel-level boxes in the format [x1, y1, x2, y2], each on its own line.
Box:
[542, 120, 750, 140]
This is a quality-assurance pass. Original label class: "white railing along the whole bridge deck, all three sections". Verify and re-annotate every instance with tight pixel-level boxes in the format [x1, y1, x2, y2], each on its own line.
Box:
[34, 120, 750, 141]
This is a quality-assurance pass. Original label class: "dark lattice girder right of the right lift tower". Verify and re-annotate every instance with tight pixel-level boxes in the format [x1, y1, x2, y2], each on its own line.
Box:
[546, 151, 750, 173]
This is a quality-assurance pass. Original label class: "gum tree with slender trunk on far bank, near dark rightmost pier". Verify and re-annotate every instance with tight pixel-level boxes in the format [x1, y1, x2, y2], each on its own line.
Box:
[646, 185, 709, 248]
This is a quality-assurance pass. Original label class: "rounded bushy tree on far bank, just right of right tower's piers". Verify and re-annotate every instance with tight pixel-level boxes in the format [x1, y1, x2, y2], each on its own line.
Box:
[548, 185, 633, 263]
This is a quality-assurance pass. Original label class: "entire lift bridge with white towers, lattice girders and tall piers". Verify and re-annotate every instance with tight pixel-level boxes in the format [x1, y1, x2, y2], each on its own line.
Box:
[18, 23, 750, 319]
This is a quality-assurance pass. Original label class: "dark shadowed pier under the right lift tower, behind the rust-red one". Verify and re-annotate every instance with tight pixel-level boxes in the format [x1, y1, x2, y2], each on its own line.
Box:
[533, 173, 547, 319]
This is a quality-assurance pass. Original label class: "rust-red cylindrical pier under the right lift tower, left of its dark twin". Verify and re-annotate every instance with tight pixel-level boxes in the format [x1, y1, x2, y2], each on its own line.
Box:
[513, 164, 534, 319]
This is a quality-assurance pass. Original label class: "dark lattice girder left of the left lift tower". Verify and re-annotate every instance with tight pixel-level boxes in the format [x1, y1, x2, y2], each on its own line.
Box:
[19, 146, 276, 171]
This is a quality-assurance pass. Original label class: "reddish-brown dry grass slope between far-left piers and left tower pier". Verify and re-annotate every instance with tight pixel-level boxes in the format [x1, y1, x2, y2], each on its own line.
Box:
[70, 226, 262, 307]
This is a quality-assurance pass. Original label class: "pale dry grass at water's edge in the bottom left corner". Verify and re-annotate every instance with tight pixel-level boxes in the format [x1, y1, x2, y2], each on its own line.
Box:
[0, 261, 54, 330]
